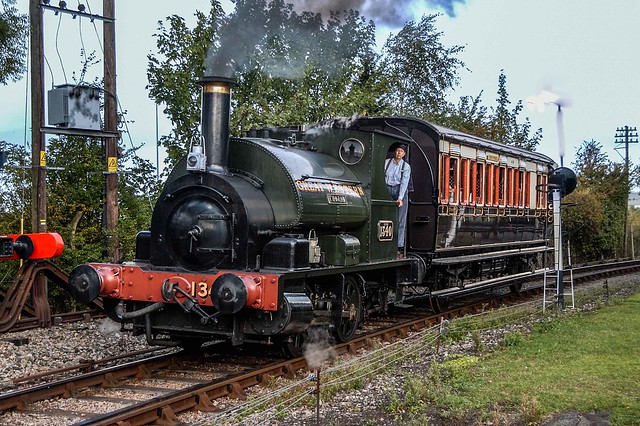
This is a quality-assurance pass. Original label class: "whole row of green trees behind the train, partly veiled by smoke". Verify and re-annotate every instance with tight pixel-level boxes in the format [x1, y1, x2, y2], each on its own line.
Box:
[147, 4, 542, 171]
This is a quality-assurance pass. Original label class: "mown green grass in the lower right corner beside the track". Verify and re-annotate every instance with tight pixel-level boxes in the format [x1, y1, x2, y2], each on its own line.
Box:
[420, 294, 640, 425]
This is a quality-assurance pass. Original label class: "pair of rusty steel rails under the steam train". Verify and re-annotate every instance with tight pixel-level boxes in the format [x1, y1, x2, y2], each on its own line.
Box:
[0, 261, 640, 426]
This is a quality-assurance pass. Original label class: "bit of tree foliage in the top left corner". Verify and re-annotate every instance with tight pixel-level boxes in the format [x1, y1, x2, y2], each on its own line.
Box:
[0, 0, 29, 84]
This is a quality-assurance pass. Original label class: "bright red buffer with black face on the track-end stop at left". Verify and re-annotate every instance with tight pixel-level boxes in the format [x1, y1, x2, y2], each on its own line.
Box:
[0, 232, 64, 261]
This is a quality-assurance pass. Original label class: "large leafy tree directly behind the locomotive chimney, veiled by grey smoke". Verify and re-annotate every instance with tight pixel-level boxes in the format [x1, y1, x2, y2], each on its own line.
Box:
[148, 0, 383, 168]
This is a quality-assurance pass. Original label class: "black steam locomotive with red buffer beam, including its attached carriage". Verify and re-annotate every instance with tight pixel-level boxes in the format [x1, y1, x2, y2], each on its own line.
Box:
[70, 78, 554, 353]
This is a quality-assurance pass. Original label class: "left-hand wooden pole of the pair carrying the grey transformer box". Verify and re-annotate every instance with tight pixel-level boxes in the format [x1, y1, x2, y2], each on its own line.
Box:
[29, 0, 47, 232]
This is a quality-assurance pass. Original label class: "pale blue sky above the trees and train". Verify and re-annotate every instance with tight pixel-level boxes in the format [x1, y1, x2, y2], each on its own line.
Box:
[0, 0, 640, 173]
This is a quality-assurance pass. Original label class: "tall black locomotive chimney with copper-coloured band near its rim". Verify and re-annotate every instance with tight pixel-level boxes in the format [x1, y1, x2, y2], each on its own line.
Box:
[198, 77, 234, 173]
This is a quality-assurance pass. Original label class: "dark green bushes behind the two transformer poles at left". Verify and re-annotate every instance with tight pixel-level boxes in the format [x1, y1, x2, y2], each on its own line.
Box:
[0, 137, 159, 309]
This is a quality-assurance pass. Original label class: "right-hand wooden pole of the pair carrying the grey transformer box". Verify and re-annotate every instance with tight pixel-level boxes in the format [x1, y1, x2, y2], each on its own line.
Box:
[103, 0, 120, 262]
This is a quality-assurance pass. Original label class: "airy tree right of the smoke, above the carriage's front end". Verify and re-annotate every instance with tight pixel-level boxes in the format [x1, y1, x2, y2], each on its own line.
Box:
[381, 15, 464, 123]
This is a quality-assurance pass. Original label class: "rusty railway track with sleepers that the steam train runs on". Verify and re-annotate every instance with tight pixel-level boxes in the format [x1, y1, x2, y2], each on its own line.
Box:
[0, 261, 640, 425]
